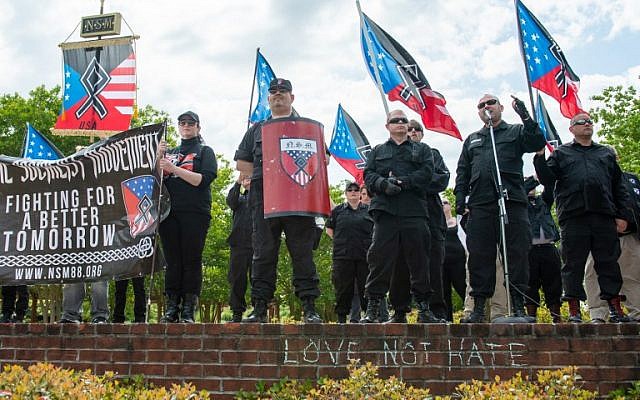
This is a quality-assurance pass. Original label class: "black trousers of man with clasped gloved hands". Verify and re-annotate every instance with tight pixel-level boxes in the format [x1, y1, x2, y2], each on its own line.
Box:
[365, 212, 432, 302]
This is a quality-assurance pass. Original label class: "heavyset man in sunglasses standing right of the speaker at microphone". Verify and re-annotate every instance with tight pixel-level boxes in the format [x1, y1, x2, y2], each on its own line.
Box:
[533, 112, 629, 323]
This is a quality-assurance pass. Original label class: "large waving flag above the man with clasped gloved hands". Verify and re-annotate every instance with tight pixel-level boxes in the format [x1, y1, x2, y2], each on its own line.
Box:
[360, 13, 462, 140]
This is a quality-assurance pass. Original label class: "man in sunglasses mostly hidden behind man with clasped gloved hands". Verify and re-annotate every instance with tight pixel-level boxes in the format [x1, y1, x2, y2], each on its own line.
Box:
[389, 119, 450, 323]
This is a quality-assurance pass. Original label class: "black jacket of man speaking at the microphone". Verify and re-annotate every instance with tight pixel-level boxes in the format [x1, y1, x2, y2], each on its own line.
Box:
[454, 118, 545, 210]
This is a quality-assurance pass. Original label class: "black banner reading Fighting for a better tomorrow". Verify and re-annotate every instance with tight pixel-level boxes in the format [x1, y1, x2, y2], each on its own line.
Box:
[0, 124, 168, 285]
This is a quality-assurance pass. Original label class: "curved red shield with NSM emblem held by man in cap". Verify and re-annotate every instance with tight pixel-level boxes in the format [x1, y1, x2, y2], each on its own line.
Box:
[262, 118, 331, 218]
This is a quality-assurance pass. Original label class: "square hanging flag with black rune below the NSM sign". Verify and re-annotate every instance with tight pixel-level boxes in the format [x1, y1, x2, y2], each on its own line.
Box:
[54, 39, 136, 132]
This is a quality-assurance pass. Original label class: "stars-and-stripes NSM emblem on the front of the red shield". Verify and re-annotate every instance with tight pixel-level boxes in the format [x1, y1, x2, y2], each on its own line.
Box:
[280, 138, 319, 187]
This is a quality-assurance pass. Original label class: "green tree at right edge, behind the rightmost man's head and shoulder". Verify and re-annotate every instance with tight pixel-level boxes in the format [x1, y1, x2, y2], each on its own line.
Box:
[590, 86, 640, 175]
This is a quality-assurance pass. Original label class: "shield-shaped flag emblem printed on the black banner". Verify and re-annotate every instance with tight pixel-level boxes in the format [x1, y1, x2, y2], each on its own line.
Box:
[121, 175, 156, 238]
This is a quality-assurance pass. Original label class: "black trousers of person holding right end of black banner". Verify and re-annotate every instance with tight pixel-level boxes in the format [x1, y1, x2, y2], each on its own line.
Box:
[160, 212, 211, 296]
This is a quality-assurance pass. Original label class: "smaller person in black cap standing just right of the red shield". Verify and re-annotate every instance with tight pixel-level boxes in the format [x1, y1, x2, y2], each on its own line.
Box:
[326, 182, 373, 324]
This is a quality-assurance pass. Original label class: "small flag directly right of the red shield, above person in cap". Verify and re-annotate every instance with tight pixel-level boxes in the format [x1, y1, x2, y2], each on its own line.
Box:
[329, 104, 371, 185]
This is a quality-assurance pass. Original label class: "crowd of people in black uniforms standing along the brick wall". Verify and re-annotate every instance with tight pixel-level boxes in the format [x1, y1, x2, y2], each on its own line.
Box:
[0, 78, 640, 323]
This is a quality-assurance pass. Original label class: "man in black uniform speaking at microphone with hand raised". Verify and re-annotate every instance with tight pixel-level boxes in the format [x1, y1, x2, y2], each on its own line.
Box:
[454, 94, 545, 322]
